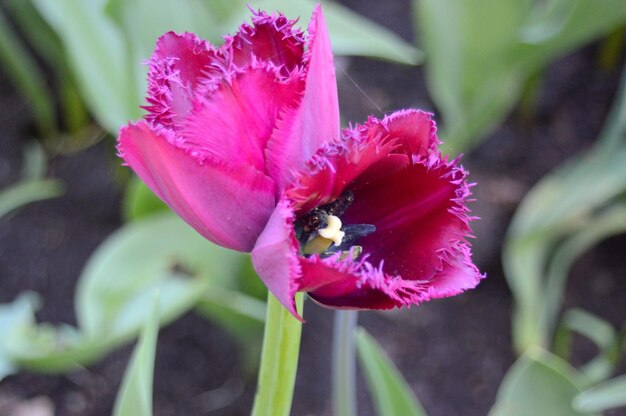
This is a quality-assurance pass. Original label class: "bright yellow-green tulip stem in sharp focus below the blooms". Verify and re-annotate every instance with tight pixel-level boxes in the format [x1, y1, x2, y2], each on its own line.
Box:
[252, 292, 303, 416]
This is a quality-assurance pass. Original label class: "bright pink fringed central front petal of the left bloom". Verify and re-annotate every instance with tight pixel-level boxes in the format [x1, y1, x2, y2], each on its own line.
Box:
[181, 67, 301, 172]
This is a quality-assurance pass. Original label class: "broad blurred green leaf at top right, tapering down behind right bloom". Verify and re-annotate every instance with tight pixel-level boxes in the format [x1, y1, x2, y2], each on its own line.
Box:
[415, 0, 626, 153]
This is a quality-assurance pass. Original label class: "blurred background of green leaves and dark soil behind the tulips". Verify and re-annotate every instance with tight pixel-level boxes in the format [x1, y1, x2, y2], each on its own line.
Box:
[0, 0, 626, 416]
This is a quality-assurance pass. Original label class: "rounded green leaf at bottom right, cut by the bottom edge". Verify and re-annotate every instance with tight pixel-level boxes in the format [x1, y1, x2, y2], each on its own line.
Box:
[489, 349, 589, 416]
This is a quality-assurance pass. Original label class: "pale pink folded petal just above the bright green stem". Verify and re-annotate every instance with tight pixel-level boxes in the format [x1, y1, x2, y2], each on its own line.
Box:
[252, 200, 302, 320]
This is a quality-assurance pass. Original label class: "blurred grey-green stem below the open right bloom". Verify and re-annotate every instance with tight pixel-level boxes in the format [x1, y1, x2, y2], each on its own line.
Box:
[333, 311, 358, 416]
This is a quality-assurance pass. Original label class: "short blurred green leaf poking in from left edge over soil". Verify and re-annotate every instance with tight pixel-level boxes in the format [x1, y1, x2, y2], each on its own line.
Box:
[0, 179, 65, 217]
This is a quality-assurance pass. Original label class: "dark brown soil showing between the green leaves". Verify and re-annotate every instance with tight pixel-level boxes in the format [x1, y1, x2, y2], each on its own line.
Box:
[0, 0, 626, 416]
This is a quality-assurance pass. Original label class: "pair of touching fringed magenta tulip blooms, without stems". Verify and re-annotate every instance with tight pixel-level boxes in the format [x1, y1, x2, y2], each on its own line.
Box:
[118, 7, 483, 316]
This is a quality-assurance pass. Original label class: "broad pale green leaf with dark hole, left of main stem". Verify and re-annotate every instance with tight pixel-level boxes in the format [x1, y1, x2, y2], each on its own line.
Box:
[76, 212, 244, 337]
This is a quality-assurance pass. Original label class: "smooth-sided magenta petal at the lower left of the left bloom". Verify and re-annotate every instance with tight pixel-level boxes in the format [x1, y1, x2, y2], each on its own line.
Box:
[118, 121, 275, 251]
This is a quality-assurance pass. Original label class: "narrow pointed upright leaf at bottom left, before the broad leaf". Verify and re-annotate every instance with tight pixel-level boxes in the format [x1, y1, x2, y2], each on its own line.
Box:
[113, 291, 159, 416]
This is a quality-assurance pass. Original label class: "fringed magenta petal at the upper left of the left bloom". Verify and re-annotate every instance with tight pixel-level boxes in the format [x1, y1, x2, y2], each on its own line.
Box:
[144, 32, 215, 127]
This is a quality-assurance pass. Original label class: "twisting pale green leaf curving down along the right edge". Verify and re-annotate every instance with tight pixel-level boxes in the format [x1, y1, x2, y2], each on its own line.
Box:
[503, 66, 626, 352]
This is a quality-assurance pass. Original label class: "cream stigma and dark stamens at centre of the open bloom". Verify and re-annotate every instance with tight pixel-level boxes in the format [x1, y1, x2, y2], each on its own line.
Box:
[294, 191, 376, 260]
